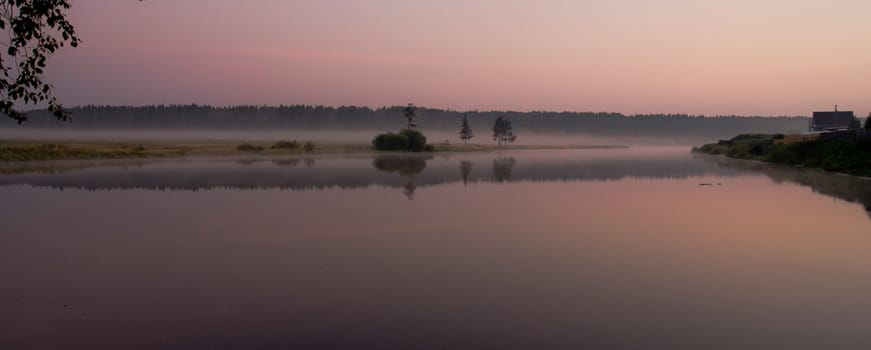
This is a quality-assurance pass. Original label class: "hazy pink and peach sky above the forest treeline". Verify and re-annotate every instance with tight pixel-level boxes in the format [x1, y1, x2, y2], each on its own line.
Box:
[47, 0, 871, 115]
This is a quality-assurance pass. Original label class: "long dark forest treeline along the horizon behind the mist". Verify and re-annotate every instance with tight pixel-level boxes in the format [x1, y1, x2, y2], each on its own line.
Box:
[6, 104, 808, 137]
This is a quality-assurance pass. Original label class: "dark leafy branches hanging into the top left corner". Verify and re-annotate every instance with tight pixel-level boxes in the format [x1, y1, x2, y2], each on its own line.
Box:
[0, 0, 80, 124]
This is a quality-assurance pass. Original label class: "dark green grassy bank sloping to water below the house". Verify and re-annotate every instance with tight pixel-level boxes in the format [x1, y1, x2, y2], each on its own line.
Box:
[693, 134, 871, 176]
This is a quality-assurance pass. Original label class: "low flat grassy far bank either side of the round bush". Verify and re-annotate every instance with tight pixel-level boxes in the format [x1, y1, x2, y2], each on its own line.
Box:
[0, 140, 626, 161]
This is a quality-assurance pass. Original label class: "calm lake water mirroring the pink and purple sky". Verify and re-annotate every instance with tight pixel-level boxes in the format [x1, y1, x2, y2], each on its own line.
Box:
[0, 148, 871, 349]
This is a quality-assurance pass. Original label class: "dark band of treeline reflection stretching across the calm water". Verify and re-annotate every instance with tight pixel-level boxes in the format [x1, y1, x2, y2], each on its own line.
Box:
[0, 150, 871, 223]
